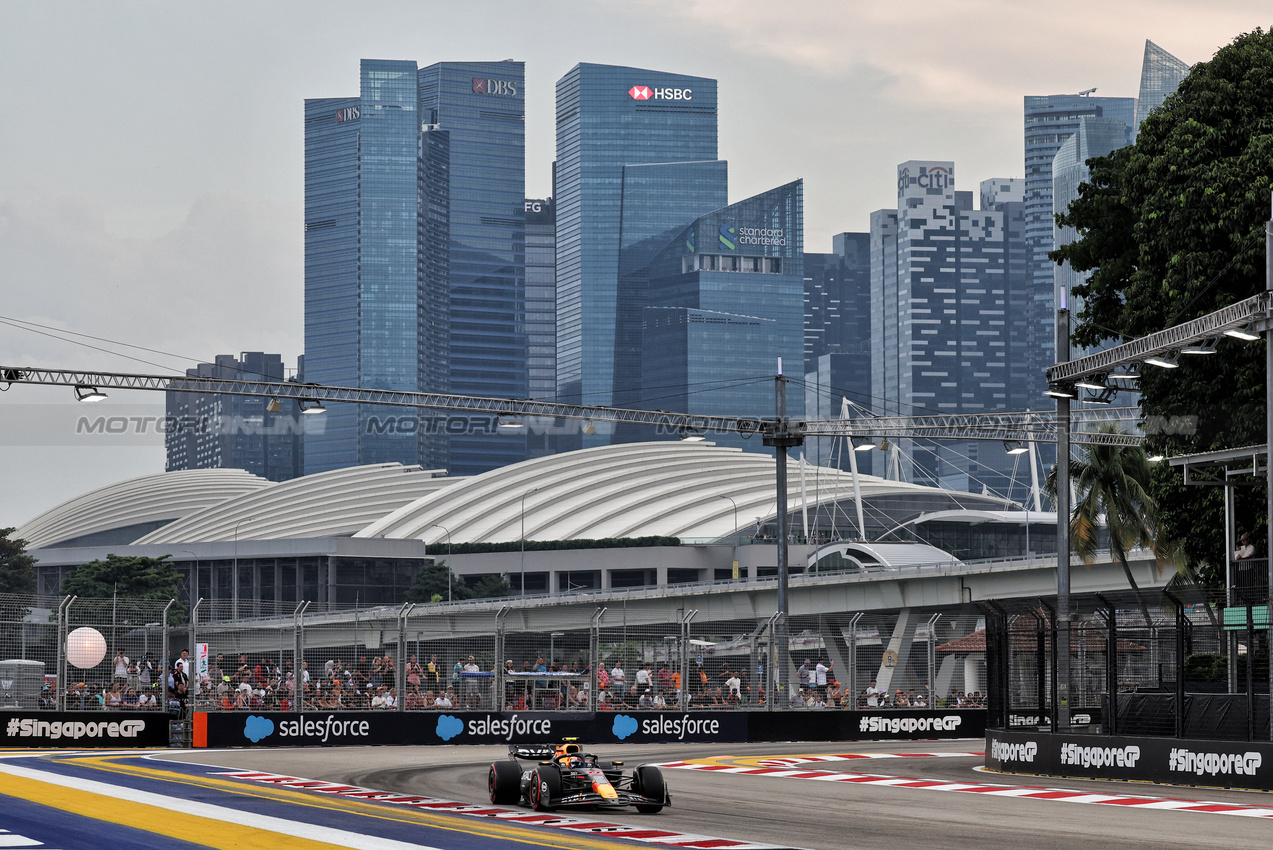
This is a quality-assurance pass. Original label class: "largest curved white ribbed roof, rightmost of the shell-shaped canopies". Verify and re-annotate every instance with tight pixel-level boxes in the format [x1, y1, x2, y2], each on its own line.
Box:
[355, 442, 1003, 545]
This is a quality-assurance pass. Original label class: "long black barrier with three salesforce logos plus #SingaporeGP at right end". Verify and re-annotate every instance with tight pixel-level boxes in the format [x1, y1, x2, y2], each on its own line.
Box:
[193, 709, 985, 747]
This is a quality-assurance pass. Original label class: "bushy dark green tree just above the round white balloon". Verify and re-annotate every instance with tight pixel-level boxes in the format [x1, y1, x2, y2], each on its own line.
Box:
[62, 555, 186, 624]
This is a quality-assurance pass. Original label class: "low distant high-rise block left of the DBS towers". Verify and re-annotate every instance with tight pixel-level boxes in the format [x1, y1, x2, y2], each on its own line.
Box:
[164, 351, 304, 481]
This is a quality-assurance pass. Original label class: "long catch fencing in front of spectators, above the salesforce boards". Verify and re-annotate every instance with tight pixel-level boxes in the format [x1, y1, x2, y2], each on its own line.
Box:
[0, 596, 985, 716]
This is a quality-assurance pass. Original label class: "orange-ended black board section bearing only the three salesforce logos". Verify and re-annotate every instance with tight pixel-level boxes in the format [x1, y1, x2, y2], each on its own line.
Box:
[195, 711, 747, 747]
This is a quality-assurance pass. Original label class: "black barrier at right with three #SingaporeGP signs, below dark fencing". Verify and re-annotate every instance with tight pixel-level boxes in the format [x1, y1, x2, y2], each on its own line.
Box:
[985, 729, 1273, 791]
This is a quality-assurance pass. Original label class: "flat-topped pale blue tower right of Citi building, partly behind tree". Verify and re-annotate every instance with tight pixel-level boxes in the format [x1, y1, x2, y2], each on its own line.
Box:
[1022, 89, 1136, 398]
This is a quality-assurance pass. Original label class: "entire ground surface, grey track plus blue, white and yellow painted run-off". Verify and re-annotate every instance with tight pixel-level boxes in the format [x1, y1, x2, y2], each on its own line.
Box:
[0, 739, 1273, 850]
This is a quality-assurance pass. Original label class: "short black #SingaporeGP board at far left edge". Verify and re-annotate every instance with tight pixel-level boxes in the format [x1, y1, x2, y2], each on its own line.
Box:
[0, 711, 168, 749]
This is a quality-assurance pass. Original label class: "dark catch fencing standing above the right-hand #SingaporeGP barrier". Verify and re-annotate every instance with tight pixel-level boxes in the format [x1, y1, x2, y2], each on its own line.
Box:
[985, 589, 1269, 741]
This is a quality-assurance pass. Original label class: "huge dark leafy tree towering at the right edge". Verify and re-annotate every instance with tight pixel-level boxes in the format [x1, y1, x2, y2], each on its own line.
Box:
[1051, 29, 1273, 584]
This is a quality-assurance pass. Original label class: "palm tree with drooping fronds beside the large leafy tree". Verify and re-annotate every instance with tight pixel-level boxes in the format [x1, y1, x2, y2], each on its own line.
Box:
[1046, 424, 1178, 624]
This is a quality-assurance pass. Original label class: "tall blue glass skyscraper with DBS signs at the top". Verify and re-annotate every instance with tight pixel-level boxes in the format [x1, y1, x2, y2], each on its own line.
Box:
[306, 60, 527, 473]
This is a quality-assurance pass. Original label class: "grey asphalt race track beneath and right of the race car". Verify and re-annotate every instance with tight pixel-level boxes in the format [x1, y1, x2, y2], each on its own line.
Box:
[161, 739, 1273, 850]
